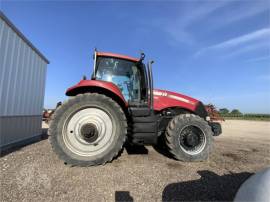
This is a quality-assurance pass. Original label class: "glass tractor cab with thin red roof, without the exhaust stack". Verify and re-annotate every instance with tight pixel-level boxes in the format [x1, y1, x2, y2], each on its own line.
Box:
[94, 53, 147, 102]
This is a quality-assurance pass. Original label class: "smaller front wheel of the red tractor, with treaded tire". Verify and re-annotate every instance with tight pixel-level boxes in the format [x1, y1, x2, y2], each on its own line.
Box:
[165, 114, 213, 161]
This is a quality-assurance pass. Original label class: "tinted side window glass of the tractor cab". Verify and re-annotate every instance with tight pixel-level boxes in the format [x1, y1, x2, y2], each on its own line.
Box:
[96, 57, 142, 101]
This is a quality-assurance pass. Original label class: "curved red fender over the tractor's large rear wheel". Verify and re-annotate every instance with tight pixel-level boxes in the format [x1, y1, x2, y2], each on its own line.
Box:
[66, 80, 128, 106]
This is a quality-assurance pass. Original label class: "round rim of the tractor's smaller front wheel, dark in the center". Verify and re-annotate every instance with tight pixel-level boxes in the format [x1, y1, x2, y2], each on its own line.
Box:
[179, 125, 206, 155]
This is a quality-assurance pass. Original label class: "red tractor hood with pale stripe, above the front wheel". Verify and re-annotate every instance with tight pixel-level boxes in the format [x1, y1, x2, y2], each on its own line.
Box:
[153, 89, 202, 112]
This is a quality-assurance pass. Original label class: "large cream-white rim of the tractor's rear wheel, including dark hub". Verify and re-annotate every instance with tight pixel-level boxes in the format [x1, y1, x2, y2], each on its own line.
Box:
[62, 108, 115, 157]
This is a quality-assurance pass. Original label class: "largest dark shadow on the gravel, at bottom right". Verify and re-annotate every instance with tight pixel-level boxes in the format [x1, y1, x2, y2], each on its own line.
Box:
[162, 170, 252, 201]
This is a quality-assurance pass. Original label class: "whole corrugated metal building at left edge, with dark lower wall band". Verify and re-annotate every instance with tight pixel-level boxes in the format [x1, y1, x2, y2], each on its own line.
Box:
[0, 11, 49, 150]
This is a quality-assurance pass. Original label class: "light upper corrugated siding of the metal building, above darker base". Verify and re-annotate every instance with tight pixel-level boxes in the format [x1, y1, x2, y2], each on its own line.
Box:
[0, 18, 47, 117]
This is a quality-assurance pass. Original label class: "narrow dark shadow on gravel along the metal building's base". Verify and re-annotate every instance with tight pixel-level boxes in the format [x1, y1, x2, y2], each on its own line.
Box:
[0, 128, 48, 157]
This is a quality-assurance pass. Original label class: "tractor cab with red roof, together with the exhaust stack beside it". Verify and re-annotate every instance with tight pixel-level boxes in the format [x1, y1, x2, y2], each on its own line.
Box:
[92, 51, 153, 111]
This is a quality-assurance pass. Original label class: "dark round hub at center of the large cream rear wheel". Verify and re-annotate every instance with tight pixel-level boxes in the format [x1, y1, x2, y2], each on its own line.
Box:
[80, 123, 98, 143]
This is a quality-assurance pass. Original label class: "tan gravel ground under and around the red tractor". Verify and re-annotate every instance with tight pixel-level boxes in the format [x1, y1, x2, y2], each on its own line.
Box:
[0, 120, 270, 201]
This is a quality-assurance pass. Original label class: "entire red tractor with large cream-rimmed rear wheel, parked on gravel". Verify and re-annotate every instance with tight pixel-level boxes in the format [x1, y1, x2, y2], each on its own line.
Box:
[49, 51, 221, 166]
